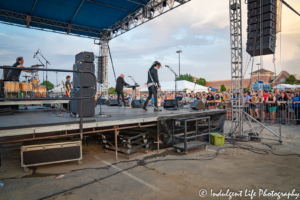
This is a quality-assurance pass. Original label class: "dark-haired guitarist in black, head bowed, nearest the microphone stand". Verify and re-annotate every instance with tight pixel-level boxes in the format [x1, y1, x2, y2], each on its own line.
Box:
[142, 61, 161, 112]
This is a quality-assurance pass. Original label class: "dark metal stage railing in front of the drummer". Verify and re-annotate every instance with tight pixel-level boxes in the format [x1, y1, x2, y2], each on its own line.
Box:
[0, 66, 97, 139]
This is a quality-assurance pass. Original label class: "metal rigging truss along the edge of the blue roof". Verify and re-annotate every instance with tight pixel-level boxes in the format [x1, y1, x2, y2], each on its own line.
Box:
[0, 0, 191, 40]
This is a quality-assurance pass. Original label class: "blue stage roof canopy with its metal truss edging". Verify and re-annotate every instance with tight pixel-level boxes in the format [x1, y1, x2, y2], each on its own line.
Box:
[0, 0, 190, 40]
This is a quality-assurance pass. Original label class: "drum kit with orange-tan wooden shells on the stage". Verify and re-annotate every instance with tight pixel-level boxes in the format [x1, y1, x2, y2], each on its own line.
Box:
[4, 65, 47, 98]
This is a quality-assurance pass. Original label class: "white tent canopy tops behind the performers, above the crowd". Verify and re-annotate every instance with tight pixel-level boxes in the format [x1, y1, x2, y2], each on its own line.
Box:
[139, 80, 208, 92]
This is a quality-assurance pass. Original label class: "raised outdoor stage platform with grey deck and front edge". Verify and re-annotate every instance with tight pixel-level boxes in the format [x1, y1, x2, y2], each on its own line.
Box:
[0, 105, 225, 144]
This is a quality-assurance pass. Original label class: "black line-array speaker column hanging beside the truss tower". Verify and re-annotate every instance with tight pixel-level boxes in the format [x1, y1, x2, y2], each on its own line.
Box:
[246, 0, 277, 56]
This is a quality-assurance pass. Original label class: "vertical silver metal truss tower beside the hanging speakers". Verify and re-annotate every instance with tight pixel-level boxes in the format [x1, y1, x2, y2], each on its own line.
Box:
[229, 0, 244, 136]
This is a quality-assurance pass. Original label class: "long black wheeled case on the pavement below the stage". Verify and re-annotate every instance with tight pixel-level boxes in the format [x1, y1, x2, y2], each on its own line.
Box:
[21, 141, 82, 172]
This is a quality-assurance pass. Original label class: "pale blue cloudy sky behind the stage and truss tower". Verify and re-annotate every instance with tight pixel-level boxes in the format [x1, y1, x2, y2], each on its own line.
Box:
[0, 0, 300, 86]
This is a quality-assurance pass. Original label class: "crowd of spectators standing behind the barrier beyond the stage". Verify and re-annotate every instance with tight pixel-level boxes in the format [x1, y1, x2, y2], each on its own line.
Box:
[96, 89, 300, 124]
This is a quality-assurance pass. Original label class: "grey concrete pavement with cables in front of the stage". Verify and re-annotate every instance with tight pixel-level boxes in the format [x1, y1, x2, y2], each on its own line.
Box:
[0, 122, 300, 200]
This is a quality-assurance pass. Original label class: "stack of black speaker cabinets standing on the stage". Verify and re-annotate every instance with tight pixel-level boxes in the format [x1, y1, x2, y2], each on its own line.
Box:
[70, 52, 96, 117]
